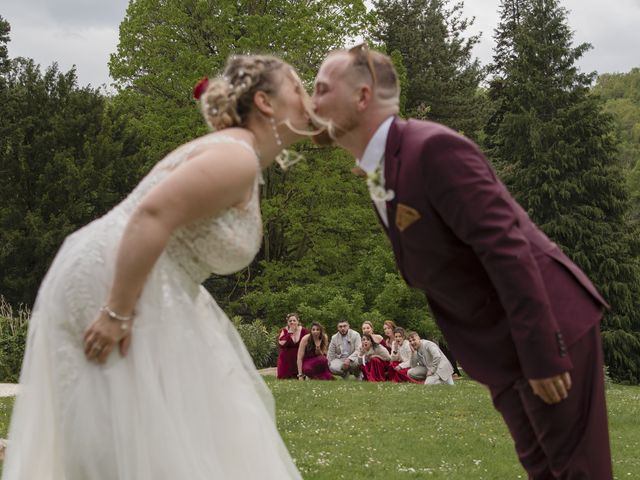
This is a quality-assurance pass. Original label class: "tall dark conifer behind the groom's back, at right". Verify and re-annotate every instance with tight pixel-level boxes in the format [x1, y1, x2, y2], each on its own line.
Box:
[487, 0, 640, 382]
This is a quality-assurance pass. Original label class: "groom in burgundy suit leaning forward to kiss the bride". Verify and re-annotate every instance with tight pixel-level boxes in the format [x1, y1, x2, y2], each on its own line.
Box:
[313, 45, 612, 480]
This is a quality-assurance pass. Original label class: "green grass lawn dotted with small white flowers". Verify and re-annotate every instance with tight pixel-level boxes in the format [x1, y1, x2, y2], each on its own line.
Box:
[0, 377, 640, 480]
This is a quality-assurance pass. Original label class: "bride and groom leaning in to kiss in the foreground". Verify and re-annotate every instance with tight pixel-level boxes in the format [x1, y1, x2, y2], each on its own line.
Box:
[3, 45, 612, 480]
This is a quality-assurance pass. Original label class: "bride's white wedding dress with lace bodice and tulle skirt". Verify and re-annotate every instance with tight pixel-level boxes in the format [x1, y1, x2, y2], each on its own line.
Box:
[3, 134, 300, 480]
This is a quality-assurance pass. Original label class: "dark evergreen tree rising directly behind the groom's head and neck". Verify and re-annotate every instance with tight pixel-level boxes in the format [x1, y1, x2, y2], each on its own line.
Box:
[373, 0, 486, 137]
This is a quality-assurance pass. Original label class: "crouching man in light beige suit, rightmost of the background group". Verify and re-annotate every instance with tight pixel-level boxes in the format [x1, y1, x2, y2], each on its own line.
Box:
[407, 332, 453, 385]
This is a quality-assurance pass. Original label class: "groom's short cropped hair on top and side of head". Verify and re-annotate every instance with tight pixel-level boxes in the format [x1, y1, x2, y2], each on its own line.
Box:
[332, 43, 400, 108]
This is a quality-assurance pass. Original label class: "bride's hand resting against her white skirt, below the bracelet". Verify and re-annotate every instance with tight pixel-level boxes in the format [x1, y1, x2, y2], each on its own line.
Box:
[84, 311, 131, 363]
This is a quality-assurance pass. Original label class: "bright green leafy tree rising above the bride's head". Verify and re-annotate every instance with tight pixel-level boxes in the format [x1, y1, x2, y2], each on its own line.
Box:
[109, 0, 368, 165]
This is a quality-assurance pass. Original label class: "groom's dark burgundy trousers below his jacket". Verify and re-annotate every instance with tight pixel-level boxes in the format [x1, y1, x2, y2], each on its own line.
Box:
[490, 325, 613, 480]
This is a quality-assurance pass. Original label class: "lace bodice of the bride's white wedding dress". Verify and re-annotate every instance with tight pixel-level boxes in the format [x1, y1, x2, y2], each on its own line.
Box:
[116, 134, 262, 283]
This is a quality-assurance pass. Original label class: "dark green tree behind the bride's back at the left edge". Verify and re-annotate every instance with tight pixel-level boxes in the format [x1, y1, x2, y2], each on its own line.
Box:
[0, 52, 144, 305]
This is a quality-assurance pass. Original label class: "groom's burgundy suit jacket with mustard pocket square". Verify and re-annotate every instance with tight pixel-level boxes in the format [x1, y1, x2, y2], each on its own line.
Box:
[384, 118, 607, 386]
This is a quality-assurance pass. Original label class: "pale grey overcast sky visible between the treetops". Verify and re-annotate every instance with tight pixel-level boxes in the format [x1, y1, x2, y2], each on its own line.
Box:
[0, 0, 640, 86]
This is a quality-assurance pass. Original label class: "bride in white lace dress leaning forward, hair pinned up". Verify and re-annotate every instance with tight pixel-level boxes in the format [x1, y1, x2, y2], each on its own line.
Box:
[3, 56, 313, 480]
